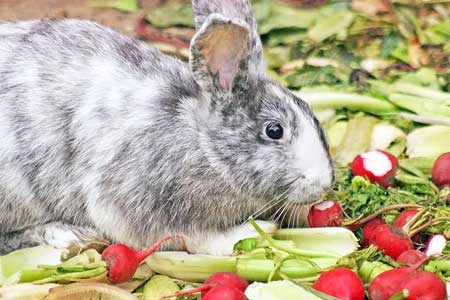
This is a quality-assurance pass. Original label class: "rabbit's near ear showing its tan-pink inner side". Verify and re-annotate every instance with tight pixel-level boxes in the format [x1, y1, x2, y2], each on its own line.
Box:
[189, 14, 250, 93]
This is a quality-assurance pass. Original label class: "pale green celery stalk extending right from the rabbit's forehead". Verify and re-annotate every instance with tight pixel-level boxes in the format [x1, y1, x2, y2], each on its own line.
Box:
[296, 91, 398, 115]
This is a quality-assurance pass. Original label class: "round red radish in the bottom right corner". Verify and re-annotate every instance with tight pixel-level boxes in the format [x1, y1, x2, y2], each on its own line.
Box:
[403, 271, 447, 300]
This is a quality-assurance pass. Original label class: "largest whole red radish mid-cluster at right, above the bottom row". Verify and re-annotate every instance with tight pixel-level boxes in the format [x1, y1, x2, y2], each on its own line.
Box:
[372, 224, 413, 259]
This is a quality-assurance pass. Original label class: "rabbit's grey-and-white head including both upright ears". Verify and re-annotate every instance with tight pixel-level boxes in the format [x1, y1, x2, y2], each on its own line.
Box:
[190, 0, 333, 203]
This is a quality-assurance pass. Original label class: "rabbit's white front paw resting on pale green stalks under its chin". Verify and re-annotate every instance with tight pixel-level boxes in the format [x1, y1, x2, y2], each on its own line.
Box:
[186, 220, 277, 256]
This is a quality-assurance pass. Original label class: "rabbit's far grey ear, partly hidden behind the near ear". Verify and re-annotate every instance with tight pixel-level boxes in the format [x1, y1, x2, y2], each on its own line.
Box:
[192, 0, 267, 74]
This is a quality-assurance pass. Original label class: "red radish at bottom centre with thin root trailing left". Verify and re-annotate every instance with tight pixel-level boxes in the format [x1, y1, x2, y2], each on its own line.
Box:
[162, 272, 248, 298]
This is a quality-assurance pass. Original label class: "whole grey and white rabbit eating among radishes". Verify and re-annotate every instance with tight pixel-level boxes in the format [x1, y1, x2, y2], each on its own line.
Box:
[0, 0, 333, 254]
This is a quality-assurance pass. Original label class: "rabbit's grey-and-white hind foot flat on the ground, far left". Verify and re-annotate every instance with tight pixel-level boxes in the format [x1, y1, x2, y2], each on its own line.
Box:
[0, 222, 103, 255]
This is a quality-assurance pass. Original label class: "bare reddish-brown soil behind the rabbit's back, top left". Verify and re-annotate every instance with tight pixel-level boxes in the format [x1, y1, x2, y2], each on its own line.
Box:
[0, 0, 141, 36]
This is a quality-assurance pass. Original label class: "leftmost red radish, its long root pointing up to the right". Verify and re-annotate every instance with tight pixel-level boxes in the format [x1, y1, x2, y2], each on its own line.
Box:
[102, 236, 178, 284]
